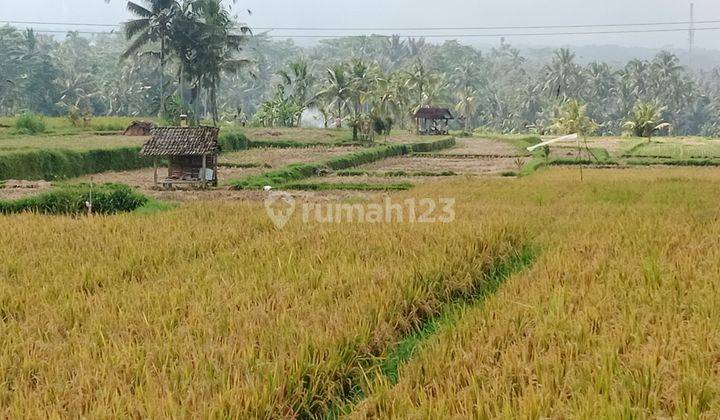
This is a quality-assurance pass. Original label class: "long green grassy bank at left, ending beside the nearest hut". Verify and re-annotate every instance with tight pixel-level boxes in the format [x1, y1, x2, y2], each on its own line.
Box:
[0, 147, 152, 181]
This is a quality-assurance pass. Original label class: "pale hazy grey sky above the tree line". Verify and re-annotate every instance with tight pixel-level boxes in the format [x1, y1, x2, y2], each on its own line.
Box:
[5, 0, 720, 49]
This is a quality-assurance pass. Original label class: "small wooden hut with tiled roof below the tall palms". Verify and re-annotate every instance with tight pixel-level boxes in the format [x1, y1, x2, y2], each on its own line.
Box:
[140, 126, 220, 188]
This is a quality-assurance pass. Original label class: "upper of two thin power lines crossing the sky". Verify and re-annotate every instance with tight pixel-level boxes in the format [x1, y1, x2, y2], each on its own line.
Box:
[0, 20, 720, 32]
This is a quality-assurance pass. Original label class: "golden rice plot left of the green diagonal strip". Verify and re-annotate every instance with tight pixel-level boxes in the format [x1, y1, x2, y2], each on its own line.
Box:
[0, 193, 528, 418]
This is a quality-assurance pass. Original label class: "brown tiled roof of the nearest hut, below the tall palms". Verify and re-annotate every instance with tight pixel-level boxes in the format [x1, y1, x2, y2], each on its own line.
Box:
[140, 126, 220, 156]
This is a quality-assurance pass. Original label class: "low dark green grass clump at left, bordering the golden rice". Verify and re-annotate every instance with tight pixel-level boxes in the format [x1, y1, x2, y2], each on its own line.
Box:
[0, 184, 148, 214]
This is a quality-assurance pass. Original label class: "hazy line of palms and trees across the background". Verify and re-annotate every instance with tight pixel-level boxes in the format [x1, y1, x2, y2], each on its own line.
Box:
[0, 0, 720, 136]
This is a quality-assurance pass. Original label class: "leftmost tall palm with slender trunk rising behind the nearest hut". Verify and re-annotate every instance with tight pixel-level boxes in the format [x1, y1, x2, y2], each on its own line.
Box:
[122, 0, 181, 114]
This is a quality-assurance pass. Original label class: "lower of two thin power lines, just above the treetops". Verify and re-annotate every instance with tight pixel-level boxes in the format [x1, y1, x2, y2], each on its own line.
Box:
[23, 26, 720, 39]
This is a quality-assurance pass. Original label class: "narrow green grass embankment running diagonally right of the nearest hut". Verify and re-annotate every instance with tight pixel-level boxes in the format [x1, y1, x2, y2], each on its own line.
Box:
[230, 138, 455, 190]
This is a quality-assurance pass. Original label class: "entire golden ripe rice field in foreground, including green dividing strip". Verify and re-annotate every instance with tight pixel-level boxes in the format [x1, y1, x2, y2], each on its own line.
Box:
[0, 168, 720, 418]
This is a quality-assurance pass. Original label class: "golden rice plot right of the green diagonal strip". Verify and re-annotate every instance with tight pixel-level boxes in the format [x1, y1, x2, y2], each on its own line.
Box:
[353, 169, 720, 418]
